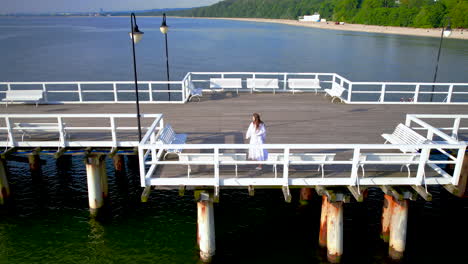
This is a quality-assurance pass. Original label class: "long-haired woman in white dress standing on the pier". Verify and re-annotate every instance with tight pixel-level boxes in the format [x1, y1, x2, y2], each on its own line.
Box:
[245, 113, 268, 170]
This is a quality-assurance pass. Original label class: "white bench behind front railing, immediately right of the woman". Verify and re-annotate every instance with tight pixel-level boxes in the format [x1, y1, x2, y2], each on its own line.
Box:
[268, 153, 336, 178]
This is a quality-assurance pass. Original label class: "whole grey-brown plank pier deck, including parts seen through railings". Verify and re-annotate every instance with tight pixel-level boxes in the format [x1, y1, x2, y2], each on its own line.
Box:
[2, 92, 468, 184]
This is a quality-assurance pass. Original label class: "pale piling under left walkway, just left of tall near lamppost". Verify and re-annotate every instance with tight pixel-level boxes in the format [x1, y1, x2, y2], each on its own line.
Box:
[85, 156, 107, 216]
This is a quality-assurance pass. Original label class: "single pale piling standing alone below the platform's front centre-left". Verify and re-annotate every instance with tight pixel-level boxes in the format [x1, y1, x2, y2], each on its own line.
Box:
[197, 192, 216, 262]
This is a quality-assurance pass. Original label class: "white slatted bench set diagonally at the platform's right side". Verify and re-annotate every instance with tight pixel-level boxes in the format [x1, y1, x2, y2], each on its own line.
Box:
[382, 123, 431, 153]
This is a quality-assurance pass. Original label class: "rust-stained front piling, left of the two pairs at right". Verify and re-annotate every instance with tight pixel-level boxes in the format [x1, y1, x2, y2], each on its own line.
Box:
[327, 202, 343, 263]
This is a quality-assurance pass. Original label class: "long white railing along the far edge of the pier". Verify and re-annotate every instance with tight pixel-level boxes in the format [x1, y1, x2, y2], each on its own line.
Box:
[0, 72, 468, 105]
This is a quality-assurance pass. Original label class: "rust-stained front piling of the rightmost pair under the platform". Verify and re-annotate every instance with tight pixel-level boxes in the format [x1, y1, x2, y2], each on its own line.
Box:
[389, 199, 409, 260]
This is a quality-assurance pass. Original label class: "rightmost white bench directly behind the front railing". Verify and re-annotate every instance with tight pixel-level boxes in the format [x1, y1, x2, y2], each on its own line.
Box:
[359, 153, 421, 178]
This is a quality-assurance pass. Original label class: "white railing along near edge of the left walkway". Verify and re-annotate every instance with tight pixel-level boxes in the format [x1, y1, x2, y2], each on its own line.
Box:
[0, 114, 163, 147]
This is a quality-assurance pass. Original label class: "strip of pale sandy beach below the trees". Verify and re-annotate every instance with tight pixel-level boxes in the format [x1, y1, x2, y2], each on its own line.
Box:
[174, 17, 468, 40]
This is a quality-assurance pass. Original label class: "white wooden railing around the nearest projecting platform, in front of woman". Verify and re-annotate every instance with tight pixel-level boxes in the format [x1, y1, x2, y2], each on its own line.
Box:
[139, 113, 467, 190]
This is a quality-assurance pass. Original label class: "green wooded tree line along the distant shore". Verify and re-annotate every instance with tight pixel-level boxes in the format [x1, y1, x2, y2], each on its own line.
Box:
[145, 0, 468, 28]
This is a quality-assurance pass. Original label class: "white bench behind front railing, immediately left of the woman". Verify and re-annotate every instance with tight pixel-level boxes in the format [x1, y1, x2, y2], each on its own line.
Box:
[179, 153, 247, 178]
